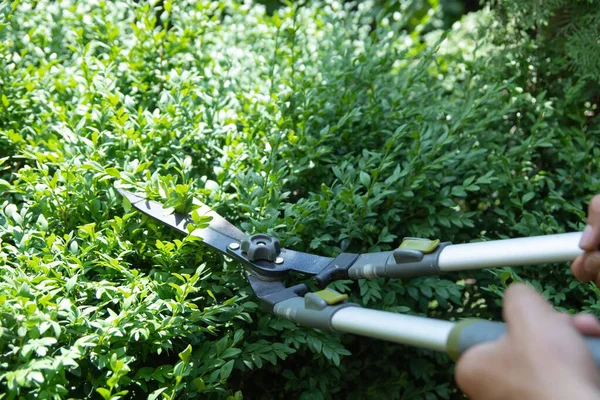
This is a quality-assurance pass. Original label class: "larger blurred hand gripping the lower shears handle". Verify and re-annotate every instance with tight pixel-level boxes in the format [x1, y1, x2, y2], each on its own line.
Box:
[456, 284, 600, 400]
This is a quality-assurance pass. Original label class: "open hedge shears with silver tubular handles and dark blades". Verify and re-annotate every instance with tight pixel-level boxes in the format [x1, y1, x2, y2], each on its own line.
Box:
[118, 189, 600, 366]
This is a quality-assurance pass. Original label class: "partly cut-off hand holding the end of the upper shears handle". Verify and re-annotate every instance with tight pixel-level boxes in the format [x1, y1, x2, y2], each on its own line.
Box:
[571, 195, 600, 286]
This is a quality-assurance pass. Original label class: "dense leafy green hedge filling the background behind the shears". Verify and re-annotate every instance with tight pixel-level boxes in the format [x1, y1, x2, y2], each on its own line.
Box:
[0, 0, 600, 399]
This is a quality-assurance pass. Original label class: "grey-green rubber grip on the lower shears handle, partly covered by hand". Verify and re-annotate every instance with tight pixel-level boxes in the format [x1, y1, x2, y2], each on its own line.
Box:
[446, 319, 600, 368]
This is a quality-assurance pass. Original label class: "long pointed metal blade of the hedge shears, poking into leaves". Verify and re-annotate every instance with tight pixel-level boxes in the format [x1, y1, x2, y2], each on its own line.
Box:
[117, 189, 246, 253]
